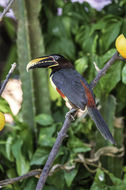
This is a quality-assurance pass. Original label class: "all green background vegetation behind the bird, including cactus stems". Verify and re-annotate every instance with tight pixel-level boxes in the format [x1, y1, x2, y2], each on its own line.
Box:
[0, 0, 126, 190]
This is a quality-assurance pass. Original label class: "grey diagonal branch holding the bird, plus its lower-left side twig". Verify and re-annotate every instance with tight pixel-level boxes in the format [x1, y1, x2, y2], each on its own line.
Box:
[0, 52, 122, 190]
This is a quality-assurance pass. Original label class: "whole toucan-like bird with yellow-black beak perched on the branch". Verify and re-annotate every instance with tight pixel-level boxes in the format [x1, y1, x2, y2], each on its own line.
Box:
[26, 54, 116, 144]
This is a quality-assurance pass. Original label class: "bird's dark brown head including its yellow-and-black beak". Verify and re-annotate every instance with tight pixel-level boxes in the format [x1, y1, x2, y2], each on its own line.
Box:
[26, 54, 73, 71]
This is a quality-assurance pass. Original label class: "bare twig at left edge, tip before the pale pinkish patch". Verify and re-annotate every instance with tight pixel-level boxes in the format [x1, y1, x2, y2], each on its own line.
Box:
[0, 63, 16, 96]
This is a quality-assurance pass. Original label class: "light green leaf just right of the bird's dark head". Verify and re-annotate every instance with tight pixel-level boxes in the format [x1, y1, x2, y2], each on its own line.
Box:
[75, 56, 88, 74]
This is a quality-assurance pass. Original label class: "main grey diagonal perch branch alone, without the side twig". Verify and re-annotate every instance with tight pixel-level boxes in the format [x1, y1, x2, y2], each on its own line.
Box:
[36, 52, 120, 190]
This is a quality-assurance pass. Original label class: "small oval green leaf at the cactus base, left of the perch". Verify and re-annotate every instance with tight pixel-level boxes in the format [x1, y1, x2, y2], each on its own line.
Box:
[35, 114, 53, 126]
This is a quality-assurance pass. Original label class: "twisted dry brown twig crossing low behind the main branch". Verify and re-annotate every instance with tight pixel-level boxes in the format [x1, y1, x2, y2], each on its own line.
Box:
[0, 144, 124, 188]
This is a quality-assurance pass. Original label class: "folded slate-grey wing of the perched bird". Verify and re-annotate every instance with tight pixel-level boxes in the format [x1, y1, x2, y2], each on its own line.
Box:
[52, 69, 87, 110]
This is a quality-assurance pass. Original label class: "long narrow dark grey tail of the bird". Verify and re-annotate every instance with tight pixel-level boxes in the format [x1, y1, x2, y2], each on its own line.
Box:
[87, 107, 116, 144]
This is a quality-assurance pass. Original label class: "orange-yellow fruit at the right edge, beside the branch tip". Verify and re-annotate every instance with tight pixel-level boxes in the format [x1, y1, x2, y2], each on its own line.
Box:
[115, 34, 126, 58]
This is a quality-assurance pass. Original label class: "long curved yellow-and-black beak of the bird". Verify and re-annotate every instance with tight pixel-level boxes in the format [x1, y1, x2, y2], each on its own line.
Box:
[26, 56, 59, 72]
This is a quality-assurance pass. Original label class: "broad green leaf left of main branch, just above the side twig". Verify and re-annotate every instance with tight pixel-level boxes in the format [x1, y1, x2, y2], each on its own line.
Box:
[30, 147, 49, 165]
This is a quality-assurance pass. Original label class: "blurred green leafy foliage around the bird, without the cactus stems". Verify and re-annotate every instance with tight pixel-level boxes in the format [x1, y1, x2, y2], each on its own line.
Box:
[0, 0, 126, 190]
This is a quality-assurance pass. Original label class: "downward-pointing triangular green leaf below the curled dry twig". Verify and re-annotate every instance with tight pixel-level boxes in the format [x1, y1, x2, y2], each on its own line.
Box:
[64, 169, 78, 187]
